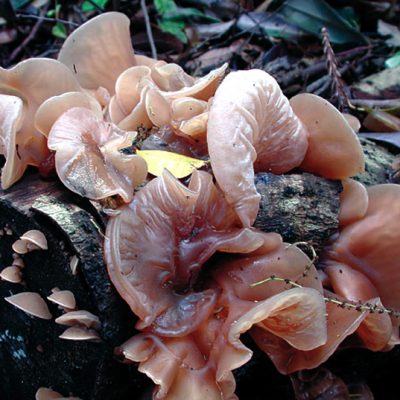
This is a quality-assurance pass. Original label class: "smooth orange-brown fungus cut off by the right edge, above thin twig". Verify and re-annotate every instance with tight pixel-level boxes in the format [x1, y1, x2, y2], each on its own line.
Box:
[323, 184, 400, 350]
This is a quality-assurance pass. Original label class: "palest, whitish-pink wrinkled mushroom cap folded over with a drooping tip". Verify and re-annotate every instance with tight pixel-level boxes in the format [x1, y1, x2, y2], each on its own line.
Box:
[207, 70, 307, 226]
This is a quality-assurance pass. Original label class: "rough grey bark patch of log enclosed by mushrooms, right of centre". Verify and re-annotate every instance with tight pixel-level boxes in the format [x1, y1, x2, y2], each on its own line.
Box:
[254, 173, 342, 251]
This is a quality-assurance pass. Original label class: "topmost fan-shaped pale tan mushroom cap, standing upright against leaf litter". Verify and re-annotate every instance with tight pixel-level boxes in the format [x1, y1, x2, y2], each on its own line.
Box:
[58, 12, 136, 94]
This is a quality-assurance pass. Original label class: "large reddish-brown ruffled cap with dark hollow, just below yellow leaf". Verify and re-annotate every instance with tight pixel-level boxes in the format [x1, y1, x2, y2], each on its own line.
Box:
[105, 171, 262, 336]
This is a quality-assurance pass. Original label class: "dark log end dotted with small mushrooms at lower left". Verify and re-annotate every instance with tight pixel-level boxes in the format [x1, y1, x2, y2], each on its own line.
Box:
[0, 174, 148, 400]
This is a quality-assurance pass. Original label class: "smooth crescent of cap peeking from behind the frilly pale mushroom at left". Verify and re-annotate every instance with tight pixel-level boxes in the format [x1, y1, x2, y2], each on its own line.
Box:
[35, 92, 103, 137]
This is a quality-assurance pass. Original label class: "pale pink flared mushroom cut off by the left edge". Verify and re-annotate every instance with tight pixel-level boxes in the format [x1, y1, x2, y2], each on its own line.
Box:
[0, 58, 81, 187]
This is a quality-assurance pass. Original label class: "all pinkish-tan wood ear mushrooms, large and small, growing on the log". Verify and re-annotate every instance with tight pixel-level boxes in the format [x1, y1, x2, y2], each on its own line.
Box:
[0, 13, 400, 400]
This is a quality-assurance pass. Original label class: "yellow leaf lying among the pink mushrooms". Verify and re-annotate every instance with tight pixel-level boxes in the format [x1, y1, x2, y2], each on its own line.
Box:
[136, 150, 206, 178]
